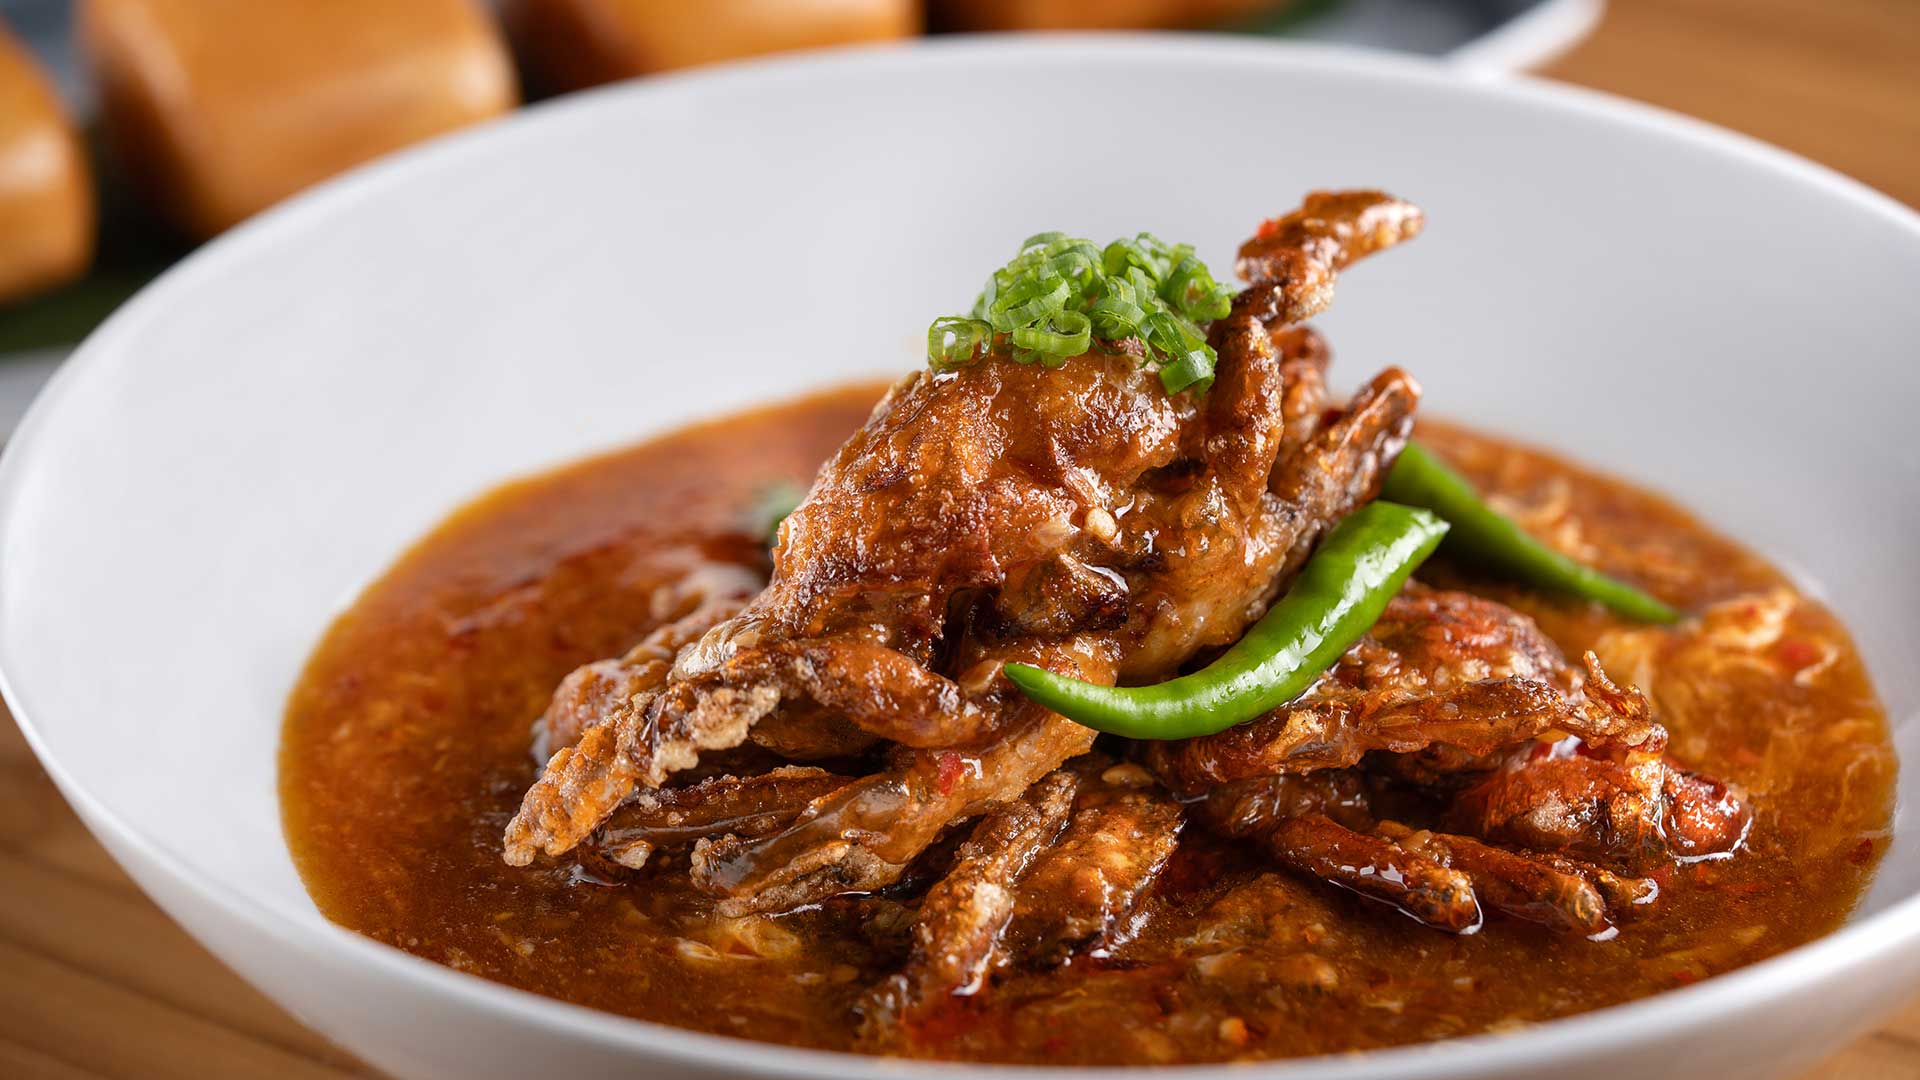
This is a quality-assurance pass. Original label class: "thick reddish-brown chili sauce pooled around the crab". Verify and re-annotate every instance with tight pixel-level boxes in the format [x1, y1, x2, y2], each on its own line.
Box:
[280, 378, 1895, 1063]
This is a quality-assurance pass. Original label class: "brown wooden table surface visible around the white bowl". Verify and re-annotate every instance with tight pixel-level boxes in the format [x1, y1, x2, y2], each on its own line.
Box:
[0, 0, 1920, 1080]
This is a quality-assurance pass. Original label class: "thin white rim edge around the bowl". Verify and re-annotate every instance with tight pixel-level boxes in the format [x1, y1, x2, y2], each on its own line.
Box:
[0, 33, 1920, 1080]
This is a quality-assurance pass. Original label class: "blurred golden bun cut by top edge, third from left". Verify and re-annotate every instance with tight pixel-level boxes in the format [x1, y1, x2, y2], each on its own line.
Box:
[507, 0, 920, 90]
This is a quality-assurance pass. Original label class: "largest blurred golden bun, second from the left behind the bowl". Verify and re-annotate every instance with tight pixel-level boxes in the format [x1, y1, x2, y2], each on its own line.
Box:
[79, 0, 518, 236]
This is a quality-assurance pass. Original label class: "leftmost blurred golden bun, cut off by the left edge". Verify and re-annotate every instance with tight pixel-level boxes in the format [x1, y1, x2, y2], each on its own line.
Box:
[0, 27, 94, 302]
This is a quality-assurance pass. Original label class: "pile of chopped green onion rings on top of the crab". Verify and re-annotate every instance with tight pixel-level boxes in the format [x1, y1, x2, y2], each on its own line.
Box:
[927, 233, 1233, 394]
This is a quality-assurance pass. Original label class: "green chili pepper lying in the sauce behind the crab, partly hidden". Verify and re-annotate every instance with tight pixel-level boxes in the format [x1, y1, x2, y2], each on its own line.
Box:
[1380, 442, 1680, 623]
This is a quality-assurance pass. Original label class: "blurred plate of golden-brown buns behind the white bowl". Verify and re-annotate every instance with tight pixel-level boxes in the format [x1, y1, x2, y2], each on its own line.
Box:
[0, 0, 1601, 428]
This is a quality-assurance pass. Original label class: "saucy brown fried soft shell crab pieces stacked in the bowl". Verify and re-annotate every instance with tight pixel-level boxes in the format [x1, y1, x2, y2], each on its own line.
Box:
[505, 192, 1751, 1042]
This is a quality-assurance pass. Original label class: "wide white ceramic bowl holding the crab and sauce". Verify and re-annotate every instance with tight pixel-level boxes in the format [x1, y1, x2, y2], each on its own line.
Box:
[0, 38, 1920, 1078]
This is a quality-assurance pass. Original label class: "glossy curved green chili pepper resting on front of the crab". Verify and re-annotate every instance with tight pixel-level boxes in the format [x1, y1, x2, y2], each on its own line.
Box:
[1006, 502, 1448, 738]
